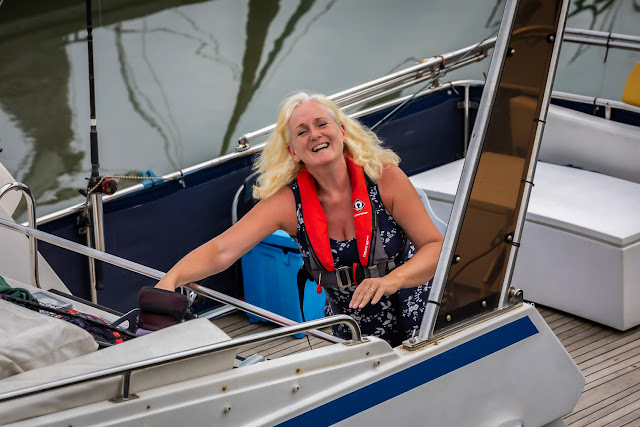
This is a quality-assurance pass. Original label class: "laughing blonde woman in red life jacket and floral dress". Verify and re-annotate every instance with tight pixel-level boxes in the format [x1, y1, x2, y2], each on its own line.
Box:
[157, 93, 442, 345]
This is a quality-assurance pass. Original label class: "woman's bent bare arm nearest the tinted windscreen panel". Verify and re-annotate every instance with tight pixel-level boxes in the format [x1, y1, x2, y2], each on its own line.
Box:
[349, 166, 443, 308]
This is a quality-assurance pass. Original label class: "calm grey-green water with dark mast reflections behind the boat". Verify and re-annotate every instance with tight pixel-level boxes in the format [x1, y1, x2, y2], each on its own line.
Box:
[0, 0, 640, 220]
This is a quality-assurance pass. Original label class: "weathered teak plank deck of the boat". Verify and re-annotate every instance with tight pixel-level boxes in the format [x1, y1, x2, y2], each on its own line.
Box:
[215, 306, 640, 427]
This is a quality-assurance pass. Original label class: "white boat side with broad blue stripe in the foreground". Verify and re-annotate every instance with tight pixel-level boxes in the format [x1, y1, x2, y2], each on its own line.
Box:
[6, 304, 584, 426]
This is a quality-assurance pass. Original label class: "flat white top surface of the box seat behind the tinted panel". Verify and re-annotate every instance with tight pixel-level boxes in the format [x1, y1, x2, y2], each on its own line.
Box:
[410, 153, 640, 247]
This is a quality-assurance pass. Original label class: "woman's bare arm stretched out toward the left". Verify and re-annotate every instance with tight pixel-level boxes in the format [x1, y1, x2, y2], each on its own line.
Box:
[156, 188, 296, 291]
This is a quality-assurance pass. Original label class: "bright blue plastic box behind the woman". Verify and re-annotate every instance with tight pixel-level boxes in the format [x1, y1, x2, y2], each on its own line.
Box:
[241, 230, 325, 338]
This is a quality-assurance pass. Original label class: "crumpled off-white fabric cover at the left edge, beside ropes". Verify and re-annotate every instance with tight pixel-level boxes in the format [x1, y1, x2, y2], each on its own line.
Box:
[0, 300, 98, 379]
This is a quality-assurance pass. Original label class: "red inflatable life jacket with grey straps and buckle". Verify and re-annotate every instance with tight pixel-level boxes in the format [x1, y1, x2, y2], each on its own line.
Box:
[297, 157, 404, 293]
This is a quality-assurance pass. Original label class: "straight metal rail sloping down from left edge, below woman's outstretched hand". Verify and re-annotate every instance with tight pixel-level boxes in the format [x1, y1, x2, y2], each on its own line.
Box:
[0, 207, 344, 343]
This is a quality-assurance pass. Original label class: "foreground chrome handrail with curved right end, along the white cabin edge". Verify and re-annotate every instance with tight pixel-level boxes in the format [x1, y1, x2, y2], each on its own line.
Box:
[0, 314, 360, 403]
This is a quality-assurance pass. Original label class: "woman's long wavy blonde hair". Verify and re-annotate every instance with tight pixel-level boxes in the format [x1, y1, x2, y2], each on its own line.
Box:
[253, 92, 400, 199]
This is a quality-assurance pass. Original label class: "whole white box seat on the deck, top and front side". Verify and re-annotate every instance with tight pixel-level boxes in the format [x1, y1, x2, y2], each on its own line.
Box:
[410, 153, 640, 330]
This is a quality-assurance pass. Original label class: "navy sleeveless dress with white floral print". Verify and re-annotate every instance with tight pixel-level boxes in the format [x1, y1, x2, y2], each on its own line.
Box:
[289, 182, 431, 346]
